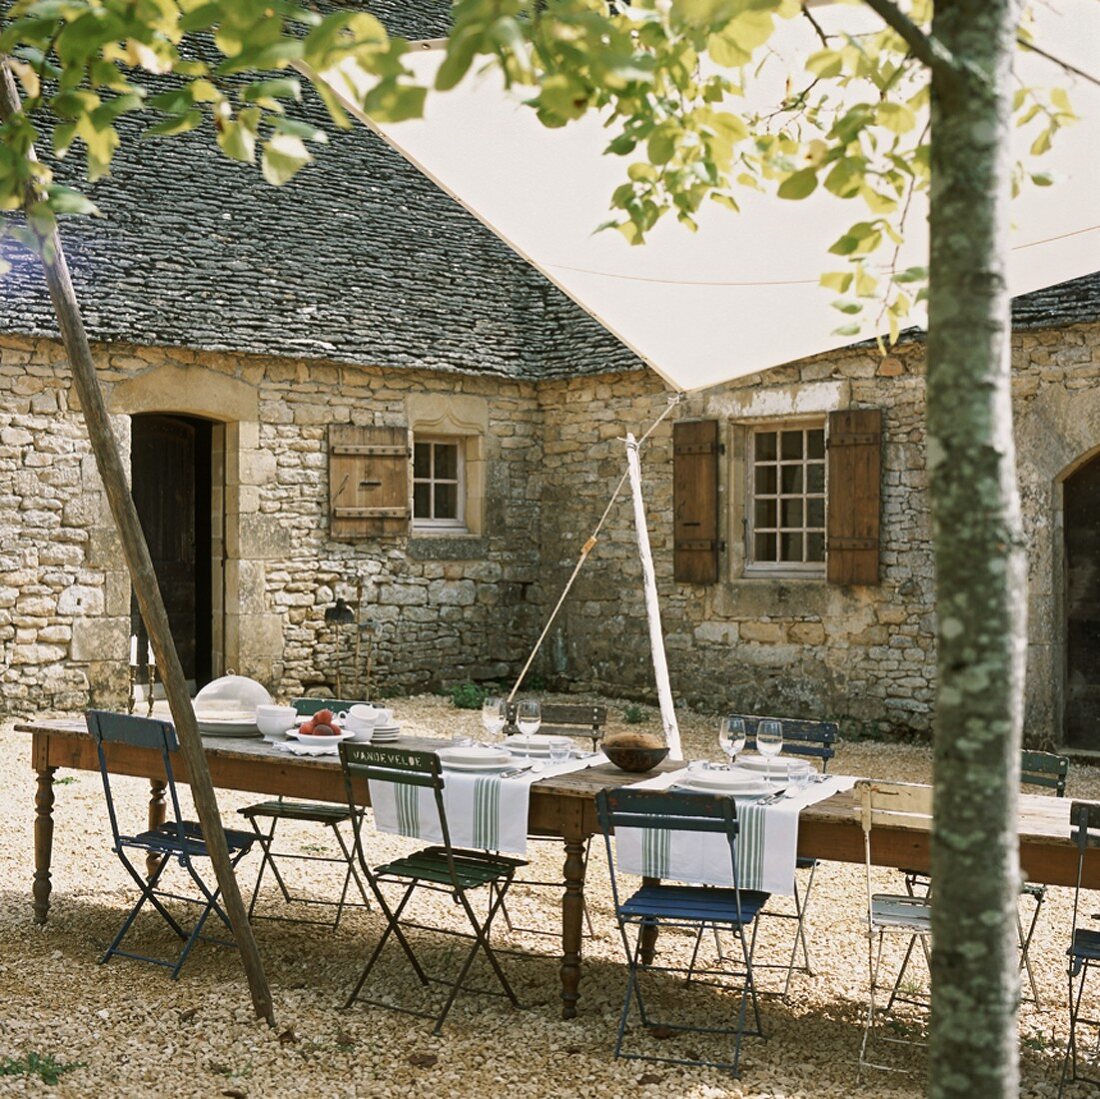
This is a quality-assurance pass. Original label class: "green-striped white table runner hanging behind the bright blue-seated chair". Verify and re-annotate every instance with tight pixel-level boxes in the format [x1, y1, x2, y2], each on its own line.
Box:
[615, 770, 856, 897]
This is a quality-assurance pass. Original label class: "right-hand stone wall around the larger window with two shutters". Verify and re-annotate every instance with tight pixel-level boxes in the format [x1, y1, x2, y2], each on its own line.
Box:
[540, 325, 1100, 744]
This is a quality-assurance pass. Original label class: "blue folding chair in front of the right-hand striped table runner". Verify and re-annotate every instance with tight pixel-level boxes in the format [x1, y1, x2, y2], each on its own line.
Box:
[596, 789, 768, 1076]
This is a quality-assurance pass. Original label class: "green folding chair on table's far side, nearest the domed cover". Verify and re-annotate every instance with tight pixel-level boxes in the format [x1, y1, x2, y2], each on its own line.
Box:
[238, 699, 371, 931]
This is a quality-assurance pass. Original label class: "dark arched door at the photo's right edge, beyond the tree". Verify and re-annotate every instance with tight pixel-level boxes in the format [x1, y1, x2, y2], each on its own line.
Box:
[1063, 458, 1100, 748]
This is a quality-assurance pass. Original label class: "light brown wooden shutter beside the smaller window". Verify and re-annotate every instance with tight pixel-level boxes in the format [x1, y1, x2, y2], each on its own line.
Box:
[329, 424, 409, 538]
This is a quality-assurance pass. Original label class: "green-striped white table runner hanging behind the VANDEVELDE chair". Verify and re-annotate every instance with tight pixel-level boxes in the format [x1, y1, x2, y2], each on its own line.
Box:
[369, 754, 607, 855]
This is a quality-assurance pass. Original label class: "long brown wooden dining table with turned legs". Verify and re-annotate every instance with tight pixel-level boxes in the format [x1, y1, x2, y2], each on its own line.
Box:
[15, 719, 1100, 1019]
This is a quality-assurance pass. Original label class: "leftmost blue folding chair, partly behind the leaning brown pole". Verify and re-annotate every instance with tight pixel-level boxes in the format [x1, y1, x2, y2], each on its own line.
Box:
[85, 710, 253, 980]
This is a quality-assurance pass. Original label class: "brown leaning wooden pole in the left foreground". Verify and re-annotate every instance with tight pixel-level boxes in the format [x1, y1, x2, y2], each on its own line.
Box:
[0, 56, 275, 1025]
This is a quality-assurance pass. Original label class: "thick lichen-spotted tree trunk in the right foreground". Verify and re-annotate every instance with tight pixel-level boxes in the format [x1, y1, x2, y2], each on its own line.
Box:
[927, 0, 1027, 1099]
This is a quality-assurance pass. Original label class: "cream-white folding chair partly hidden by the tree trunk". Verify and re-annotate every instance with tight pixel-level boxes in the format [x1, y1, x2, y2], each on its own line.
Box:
[855, 779, 932, 1077]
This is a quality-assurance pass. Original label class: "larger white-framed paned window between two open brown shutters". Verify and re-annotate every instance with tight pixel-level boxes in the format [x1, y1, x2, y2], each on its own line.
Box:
[746, 421, 825, 574]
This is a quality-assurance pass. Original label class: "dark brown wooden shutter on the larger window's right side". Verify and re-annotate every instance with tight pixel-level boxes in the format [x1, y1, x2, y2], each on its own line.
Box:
[825, 408, 882, 584]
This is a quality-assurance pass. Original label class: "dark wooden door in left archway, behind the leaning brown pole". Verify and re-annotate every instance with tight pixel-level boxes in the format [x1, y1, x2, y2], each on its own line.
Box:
[131, 415, 210, 684]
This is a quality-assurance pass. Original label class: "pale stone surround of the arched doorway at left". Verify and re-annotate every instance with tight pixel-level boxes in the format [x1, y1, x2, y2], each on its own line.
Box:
[107, 365, 285, 679]
